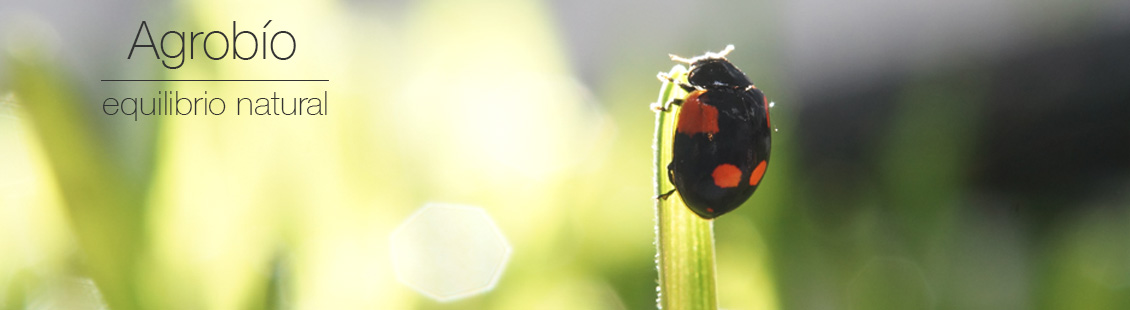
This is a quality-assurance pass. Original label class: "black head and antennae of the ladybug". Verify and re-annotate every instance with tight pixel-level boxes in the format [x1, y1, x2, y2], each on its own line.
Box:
[671, 45, 753, 88]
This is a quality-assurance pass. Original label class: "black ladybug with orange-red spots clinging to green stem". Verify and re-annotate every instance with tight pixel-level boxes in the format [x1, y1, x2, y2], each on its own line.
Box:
[659, 45, 773, 219]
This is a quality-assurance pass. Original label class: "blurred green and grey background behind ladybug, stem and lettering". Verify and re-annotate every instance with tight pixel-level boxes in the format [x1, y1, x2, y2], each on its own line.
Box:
[0, 0, 1130, 309]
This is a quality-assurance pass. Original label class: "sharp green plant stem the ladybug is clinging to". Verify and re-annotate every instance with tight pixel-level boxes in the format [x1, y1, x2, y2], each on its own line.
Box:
[652, 66, 718, 309]
